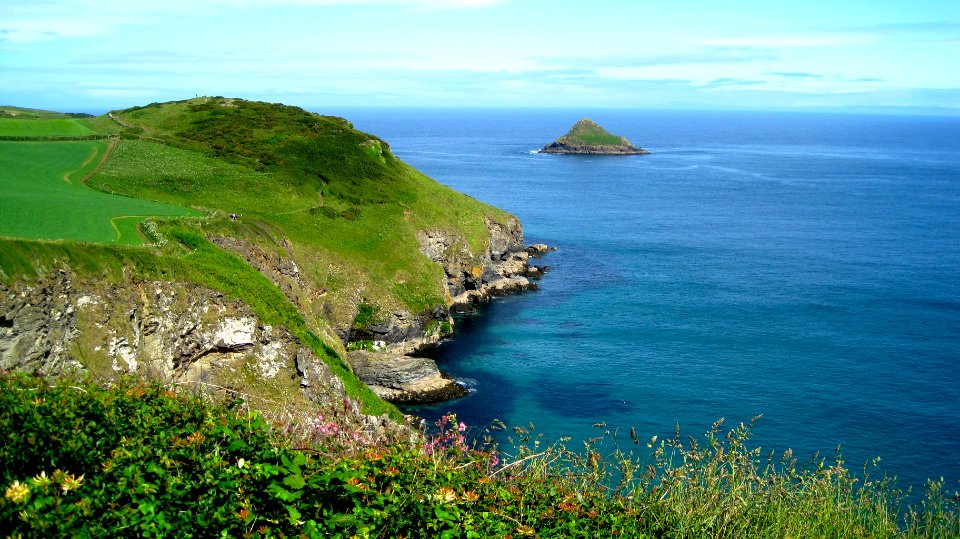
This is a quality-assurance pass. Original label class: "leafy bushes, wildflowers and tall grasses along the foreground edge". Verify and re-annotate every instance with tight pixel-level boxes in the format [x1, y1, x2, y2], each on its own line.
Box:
[0, 373, 960, 537]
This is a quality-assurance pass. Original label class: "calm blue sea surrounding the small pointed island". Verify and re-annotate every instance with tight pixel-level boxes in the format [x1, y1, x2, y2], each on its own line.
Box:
[338, 109, 960, 489]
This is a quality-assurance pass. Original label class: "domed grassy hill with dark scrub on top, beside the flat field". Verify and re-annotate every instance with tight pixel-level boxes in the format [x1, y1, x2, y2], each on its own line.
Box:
[90, 98, 508, 318]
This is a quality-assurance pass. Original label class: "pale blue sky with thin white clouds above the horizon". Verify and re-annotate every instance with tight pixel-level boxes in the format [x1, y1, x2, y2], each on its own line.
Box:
[0, 0, 960, 115]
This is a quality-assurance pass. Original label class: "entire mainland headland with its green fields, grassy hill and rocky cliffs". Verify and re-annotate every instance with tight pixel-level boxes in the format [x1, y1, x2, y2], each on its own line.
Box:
[0, 97, 540, 422]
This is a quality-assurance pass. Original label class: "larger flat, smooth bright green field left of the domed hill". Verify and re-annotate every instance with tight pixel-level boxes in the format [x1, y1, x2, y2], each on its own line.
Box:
[0, 142, 197, 245]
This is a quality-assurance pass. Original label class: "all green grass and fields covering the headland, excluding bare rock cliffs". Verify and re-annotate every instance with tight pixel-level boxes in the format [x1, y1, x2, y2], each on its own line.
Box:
[0, 98, 509, 418]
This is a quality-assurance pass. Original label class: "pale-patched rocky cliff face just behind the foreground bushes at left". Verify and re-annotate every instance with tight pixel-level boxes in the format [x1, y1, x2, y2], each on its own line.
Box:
[0, 270, 409, 442]
